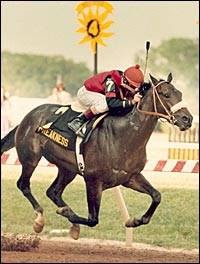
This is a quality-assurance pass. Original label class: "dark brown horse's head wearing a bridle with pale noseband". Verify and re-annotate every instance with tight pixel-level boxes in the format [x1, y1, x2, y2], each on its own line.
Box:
[147, 73, 193, 131]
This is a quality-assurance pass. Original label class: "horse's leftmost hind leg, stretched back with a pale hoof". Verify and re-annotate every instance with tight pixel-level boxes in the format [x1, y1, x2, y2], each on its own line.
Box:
[17, 164, 44, 233]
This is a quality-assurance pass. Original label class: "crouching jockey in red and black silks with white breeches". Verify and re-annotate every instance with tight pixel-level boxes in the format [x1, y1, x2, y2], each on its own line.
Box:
[68, 64, 144, 137]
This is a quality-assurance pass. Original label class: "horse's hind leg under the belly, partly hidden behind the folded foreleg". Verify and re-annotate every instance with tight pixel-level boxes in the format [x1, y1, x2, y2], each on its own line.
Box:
[46, 168, 80, 239]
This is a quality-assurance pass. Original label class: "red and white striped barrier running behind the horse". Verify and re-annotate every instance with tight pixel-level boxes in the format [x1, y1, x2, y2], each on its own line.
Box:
[1, 151, 199, 173]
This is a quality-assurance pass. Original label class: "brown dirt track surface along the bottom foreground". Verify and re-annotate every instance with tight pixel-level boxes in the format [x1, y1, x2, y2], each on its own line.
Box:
[1, 239, 199, 263]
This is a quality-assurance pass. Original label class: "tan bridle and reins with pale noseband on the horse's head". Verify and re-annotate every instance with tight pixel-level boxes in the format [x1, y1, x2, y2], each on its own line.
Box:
[137, 81, 183, 125]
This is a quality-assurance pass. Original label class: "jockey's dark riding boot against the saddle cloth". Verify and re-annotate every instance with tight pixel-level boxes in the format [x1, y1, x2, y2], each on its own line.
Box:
[68, 110, 94, 137]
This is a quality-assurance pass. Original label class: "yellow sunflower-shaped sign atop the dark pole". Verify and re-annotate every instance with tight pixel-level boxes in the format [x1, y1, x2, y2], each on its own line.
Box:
[76, 1, 113, 53]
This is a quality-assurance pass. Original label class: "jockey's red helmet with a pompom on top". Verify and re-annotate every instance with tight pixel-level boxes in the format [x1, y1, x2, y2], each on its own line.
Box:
[124, 64, 144, 88]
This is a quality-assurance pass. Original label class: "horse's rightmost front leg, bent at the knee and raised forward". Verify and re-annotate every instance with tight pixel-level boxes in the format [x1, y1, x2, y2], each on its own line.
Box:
[123, 173, 161, 227]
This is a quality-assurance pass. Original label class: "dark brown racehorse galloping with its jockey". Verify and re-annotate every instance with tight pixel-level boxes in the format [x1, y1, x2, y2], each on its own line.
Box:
[1, 73, 193, 239]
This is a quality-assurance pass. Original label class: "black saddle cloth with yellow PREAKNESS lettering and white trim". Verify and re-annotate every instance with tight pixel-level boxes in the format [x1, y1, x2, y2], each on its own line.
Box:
[36, 105, 107, 154]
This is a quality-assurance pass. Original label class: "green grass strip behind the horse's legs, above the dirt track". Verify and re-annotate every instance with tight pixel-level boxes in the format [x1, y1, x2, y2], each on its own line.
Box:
[1, 179, 199, 249]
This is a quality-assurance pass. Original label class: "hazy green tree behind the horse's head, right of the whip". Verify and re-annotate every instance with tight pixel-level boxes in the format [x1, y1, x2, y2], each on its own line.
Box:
[135, 38, 199, 113]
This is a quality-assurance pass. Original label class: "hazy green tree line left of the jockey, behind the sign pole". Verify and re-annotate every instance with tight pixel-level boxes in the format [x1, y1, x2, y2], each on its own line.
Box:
[2, 52, 91, 97]
